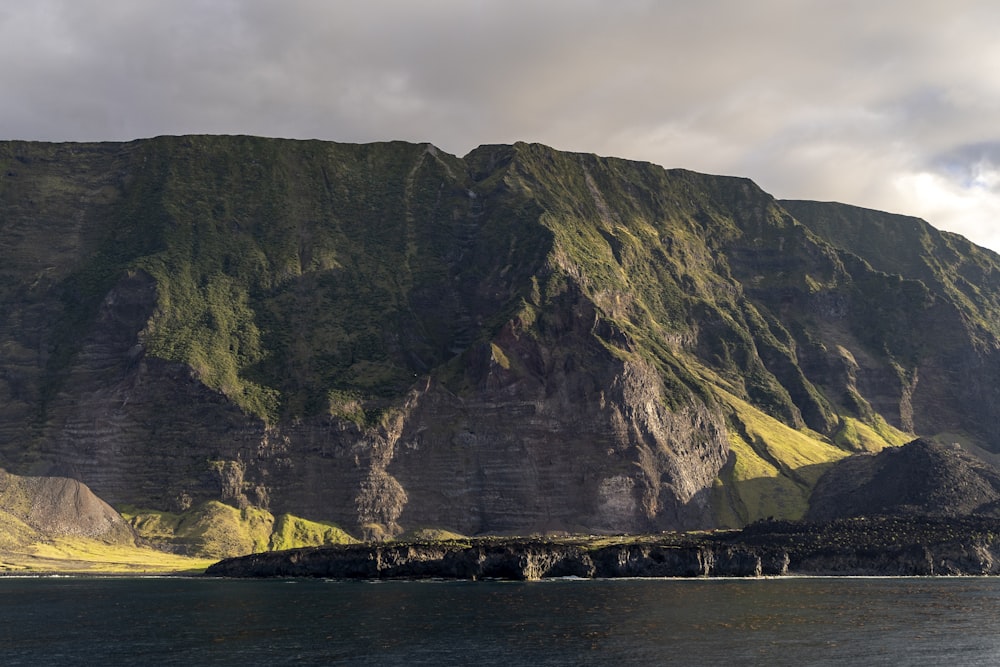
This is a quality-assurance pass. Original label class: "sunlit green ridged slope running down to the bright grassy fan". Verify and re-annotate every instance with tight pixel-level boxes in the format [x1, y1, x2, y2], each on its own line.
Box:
[474, 144, 921, 527]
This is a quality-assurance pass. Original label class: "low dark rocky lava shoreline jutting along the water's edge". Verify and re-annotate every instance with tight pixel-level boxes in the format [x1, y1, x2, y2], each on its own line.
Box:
[206, 517, 1000, 581]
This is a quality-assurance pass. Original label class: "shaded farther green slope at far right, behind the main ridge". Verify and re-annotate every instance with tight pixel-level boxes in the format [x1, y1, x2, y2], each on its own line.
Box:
[782, 201, 1000, 452]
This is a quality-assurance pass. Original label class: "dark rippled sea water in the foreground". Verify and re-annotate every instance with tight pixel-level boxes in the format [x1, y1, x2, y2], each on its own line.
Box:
[0, 578, 1000, 667]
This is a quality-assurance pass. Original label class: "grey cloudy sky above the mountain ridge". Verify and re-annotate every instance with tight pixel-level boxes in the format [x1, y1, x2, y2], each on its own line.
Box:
[0, 0, 1000, 250]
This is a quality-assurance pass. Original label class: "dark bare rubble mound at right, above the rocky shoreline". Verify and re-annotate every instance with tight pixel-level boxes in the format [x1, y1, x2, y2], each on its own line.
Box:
[806, 439, 1000, 521]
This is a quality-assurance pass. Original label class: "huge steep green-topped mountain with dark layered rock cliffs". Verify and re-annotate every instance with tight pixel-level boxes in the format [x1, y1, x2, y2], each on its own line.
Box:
[0, 136, 1000, 542]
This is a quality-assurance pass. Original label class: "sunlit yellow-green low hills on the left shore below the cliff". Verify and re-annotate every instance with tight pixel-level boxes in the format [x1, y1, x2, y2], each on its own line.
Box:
[0, 469, 354, 573]
